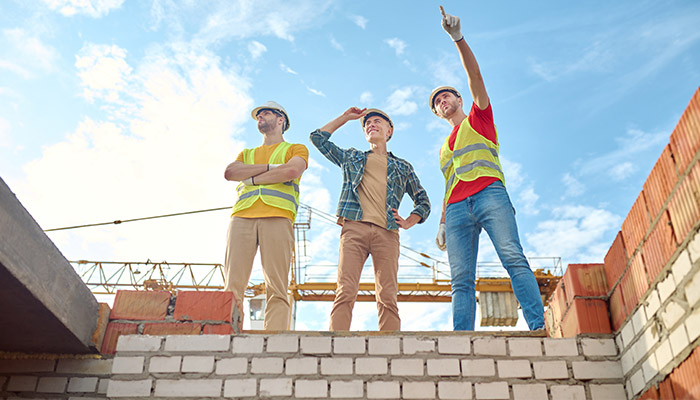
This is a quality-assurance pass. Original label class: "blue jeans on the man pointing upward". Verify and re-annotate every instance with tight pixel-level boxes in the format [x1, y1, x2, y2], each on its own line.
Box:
[445, 181, 544, 331]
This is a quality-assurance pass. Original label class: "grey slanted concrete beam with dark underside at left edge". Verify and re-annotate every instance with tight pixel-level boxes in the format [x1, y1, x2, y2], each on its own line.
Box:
[0, 178, 98, 354]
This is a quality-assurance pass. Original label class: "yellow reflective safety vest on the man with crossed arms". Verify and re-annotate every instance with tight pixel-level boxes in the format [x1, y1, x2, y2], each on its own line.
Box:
[233, 142, 299, 221]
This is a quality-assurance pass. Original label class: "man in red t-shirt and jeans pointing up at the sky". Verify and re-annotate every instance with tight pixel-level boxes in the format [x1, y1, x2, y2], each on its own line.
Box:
[430, 6, 544, 330]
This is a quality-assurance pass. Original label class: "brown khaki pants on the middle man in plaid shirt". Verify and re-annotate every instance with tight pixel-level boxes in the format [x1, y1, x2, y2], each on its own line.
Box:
[330, 220, 401, 331]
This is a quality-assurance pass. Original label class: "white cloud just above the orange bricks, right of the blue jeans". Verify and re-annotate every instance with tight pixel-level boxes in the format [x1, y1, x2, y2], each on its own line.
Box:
[525, 205, 621, 264]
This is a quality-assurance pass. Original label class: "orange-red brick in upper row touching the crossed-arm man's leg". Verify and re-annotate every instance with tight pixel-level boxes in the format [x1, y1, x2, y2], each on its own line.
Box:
[173, 291, 235, 322]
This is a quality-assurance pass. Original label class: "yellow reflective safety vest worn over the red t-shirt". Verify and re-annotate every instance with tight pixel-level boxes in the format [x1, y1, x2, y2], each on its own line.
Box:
[440, 118, 505, 200]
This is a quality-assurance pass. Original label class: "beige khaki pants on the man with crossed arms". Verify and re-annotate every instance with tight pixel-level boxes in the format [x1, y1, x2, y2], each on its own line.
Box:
[224, 217, 294, 330]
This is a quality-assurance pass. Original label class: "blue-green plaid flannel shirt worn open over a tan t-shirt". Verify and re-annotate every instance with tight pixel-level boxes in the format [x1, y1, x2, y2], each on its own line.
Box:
[311, 129, 430, 230]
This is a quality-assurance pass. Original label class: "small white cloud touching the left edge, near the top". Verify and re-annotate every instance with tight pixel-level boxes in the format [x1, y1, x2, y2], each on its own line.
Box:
[2, 28, 59, 77]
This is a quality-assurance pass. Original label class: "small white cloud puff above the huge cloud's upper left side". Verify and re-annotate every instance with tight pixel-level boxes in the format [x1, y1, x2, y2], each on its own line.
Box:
[75, 43, 132, 102]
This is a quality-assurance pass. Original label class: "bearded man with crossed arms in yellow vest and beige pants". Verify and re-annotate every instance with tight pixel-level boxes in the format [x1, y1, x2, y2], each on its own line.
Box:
[224, 101, 309, 330]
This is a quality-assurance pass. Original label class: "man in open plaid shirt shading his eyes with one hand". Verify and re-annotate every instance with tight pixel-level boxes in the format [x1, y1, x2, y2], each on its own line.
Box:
[311, 107, 430, 331]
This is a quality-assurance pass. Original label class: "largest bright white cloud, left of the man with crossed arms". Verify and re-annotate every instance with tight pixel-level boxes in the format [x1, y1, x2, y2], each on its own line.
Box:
[16, 46, 252, 262]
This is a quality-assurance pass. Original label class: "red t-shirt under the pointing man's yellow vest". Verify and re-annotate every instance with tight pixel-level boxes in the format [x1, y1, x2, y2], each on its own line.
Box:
[447, 102, 499, 204]
